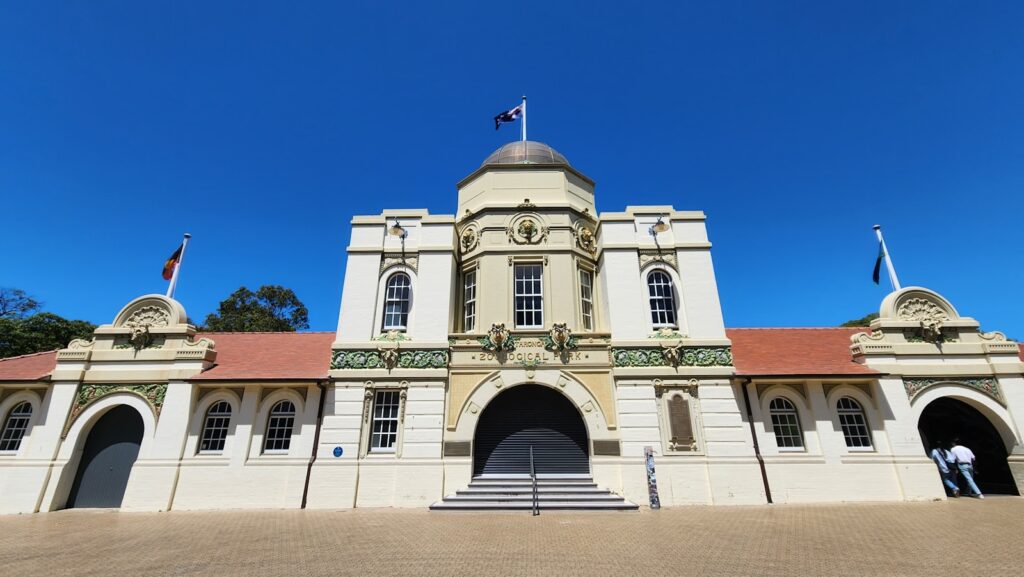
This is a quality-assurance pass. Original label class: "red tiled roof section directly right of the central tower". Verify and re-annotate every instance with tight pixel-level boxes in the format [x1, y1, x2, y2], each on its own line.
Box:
[725, 328, 881, 376]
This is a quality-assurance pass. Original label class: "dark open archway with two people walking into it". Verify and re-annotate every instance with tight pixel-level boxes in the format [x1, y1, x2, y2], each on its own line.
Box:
[918, 397, 1019, 495]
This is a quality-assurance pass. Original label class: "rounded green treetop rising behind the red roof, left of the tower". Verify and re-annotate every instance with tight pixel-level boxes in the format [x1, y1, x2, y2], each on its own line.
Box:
[203, 285, 309, 332]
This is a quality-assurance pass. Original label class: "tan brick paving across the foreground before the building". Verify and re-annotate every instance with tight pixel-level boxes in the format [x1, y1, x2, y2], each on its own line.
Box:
[0, 497, 1024, 577]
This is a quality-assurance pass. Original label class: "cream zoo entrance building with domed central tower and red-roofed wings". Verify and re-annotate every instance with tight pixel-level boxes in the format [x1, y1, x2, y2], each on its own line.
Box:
[0, 141, 1024, 513]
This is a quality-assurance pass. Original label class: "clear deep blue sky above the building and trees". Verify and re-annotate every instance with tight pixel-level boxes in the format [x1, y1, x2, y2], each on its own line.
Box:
[0, 1, 1024, 338]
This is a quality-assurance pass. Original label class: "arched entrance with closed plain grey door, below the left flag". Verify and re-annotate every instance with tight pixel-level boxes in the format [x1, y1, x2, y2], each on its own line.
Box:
[68, 405, 144, 508]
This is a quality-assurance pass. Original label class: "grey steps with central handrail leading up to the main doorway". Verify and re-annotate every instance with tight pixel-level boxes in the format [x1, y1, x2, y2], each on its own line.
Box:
[430, 477, 639, 510]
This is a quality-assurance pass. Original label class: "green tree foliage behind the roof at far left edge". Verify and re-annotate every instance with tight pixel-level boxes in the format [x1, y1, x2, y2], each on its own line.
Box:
[0, 313, 96, 358]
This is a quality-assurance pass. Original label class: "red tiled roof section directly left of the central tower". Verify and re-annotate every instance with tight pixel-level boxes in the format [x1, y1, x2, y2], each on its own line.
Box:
[191, 332, 334, 380]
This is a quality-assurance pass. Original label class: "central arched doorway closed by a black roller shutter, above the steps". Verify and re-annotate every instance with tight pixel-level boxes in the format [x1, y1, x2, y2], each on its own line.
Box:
[473, 384, 590, 477]
